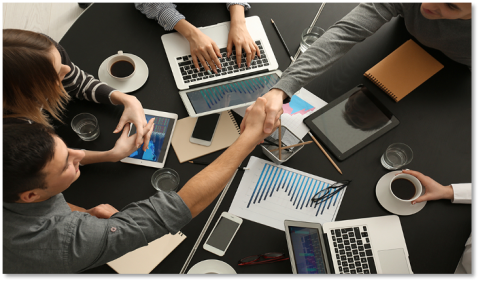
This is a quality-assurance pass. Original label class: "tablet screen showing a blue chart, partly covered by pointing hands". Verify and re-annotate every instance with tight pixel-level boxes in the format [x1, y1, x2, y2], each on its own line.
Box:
[129, 114, 174, 162]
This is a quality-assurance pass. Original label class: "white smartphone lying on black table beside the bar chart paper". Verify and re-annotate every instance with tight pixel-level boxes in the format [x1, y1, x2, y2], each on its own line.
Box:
[203, 211, 243, 256]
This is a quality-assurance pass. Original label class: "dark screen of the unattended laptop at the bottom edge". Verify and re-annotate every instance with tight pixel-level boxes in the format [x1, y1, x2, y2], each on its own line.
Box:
[288, 226, 327, 274]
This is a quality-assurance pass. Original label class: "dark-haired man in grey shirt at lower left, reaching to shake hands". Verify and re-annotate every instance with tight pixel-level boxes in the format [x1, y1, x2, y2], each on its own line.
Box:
[2, 97, 278, 273]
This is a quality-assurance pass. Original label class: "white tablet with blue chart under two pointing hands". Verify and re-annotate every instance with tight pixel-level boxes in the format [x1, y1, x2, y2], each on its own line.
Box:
[121, 109, 178, 168]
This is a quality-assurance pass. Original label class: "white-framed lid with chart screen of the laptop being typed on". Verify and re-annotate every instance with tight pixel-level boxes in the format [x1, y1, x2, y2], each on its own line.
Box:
[179, 70, 282, 117]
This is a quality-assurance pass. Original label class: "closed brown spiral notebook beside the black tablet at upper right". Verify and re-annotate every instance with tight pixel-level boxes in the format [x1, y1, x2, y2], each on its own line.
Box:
[364, 39, 443, 102]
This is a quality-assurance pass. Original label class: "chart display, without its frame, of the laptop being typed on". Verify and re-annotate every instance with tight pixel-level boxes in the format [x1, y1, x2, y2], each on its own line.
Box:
[186, 74, 280, 114]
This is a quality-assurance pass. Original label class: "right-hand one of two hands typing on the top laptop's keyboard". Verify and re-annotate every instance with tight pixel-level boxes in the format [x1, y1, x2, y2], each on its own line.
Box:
[227, 20, 261, 68]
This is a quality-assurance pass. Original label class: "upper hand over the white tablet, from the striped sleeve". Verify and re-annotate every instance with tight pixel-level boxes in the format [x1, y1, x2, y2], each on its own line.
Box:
[110, 91, 151, 151]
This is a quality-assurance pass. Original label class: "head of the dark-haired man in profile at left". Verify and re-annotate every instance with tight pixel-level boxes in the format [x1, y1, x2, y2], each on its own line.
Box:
[2, 123, 85, 203]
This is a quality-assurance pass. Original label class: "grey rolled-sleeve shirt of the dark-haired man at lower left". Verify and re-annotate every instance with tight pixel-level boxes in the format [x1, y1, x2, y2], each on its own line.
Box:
[2, 192, 192, 273]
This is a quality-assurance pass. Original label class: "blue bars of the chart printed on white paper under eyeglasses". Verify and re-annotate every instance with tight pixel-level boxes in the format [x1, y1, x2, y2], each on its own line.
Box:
[247, 164, 339, 216]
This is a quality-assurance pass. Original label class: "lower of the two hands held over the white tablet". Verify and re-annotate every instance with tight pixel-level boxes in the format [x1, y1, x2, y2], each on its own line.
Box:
[109, 118, 155, 162]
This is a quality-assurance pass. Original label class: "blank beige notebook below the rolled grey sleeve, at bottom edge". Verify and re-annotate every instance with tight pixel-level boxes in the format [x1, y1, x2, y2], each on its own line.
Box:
[107, 232, 187, 274]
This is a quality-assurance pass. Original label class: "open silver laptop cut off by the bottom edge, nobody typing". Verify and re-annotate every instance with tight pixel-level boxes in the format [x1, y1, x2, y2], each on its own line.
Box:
[285, 215, 413, 274]
